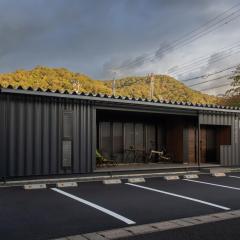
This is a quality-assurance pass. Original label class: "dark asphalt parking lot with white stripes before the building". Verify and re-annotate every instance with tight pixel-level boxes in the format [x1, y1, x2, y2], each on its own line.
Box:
[0, 173, 240, 240]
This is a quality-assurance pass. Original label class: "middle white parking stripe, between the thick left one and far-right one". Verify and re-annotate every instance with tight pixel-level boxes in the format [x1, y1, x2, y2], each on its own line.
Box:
[126, 183, 231, 211]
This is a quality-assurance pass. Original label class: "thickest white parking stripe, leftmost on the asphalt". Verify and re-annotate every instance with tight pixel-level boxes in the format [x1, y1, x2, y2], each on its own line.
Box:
[51, 188, 136, 225]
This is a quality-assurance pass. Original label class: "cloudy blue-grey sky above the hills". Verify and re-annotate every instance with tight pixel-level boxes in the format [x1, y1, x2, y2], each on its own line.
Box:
[0, 0, 240, 94]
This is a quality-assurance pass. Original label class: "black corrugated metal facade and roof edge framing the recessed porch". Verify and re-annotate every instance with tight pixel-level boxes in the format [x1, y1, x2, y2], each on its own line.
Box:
[0, 88, 240, 178]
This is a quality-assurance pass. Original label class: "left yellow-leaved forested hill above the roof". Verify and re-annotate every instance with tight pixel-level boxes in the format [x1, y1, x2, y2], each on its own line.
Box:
[0, 66, 111, 94]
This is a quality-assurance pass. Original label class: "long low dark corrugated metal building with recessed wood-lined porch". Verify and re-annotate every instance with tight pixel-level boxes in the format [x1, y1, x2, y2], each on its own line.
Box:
[0, 87, 240, 178]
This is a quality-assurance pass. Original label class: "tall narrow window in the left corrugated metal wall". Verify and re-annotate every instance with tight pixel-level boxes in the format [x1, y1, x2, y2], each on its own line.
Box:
[62, 111, 73, 168]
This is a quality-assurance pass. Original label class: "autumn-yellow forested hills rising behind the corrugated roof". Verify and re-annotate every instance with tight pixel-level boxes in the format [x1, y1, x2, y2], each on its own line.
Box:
[0, 66, 218, 103]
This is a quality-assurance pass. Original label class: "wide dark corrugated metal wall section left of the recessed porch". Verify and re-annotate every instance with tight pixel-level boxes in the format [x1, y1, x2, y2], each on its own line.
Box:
[0, 94, 96, 177]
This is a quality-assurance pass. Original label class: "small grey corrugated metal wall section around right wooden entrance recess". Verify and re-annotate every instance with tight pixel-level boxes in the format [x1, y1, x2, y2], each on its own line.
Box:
[199, 112, 240, 166]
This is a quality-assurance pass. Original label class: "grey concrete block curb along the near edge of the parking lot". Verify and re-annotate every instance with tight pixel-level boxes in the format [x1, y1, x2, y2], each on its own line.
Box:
[55, 210, 240, 240]
